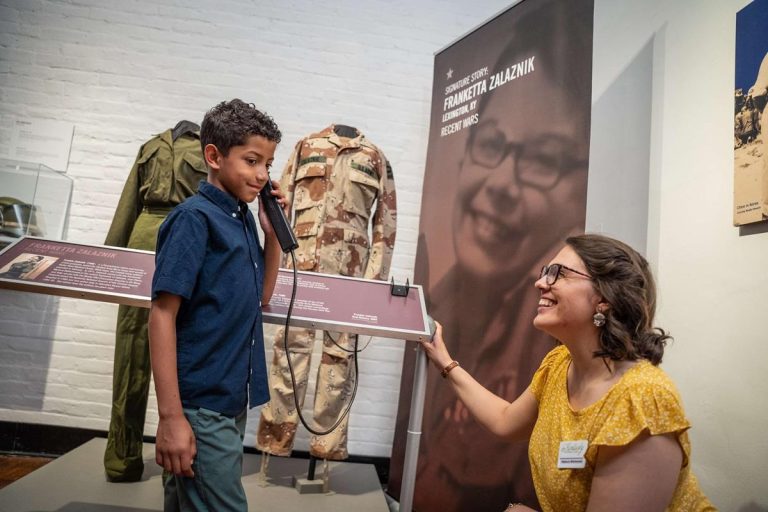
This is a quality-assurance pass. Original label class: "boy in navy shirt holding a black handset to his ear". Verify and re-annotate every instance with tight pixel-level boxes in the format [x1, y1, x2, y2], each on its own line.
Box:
[149, 99, 285, 511]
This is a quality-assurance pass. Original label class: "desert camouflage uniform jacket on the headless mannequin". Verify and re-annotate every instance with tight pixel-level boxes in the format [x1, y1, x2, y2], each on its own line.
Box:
[280, 125, 397, 280]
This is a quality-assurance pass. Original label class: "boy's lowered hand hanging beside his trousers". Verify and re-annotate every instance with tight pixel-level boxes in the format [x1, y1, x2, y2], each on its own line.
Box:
[155, 414, 197, 478]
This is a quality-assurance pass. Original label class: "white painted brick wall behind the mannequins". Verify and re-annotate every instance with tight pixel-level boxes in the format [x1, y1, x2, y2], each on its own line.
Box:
[0, 0, 512, 457]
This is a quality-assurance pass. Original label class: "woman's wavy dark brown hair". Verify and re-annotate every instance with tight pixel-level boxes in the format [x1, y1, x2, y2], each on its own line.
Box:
[565, 234, 672, 365]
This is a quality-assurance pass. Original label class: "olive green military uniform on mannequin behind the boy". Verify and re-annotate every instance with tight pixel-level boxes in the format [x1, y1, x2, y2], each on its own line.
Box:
[104, 130, 207, 481]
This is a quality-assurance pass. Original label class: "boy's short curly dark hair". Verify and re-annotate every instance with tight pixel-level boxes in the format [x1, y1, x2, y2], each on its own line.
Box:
[200, 98, 282, 156]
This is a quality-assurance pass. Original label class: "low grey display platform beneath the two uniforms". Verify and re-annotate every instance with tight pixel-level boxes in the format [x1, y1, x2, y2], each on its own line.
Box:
[0, 438, 389, 512]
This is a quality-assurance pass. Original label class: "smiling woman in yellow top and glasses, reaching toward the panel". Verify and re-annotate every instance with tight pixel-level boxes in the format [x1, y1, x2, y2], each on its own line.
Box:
[423, 235, 714, 512]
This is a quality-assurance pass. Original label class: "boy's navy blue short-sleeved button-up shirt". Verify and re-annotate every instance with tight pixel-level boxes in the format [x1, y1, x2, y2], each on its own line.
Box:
[152, 182, 269, 416]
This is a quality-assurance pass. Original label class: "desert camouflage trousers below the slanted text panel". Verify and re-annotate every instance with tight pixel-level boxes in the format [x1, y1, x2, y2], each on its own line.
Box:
[256, 327, 356, 460]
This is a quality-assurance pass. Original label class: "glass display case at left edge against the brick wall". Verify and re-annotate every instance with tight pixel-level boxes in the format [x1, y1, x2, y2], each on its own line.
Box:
[0, 158, 72, 249]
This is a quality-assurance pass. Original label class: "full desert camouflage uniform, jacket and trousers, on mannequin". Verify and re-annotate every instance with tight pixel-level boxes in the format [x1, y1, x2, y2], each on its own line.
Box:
[256, 125, 396, 460]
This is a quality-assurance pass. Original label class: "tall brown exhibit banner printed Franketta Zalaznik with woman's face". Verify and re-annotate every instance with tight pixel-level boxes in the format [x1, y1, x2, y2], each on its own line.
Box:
[389, 0, 594, 512]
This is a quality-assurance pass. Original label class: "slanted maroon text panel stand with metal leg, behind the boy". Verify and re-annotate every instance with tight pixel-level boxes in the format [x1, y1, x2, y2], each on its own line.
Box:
[0, 236, 432, 510]
